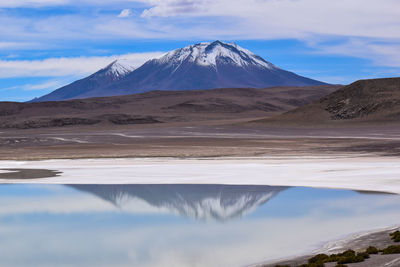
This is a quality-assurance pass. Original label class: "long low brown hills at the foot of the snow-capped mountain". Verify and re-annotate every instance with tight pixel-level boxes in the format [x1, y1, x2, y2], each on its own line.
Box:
[0, 85, 340, 129]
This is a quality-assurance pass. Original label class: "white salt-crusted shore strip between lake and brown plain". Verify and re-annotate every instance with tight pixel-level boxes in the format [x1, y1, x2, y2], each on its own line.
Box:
[0, 154, 400, 194]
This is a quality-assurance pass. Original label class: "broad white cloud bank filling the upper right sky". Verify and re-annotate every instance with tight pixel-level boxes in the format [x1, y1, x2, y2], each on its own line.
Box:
[137, 0, 400, 67]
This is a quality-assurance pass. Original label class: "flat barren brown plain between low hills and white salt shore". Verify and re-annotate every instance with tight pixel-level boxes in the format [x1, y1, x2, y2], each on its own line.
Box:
[0, 120, 400, 160]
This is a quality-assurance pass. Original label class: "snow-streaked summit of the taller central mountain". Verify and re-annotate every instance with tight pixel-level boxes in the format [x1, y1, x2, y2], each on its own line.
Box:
[158, 40, 277, 69]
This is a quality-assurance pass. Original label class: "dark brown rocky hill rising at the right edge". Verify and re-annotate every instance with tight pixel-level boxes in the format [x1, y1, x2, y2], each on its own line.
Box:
[263, 78, 400, 125]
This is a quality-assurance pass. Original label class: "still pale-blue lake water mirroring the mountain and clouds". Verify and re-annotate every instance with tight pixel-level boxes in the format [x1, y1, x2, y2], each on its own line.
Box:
[0, 184, 400, 266]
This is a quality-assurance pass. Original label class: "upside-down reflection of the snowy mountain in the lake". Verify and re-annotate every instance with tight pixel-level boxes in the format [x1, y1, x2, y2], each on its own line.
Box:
[71, 185, 287, 221]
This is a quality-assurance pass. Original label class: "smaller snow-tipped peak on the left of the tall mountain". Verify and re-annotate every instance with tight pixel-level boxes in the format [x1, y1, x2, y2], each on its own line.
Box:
[31, 59, 134, 102]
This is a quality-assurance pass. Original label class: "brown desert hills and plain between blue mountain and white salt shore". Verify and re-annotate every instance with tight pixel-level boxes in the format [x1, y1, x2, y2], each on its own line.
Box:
[0, 79, 400, 160]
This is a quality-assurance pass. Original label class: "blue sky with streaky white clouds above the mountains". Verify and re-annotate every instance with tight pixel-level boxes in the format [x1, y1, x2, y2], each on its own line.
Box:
[0, 0, 400, 101]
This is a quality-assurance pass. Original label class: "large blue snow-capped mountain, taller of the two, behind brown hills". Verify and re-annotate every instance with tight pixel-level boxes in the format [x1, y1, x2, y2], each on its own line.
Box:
[32, 41, 324, 101]
